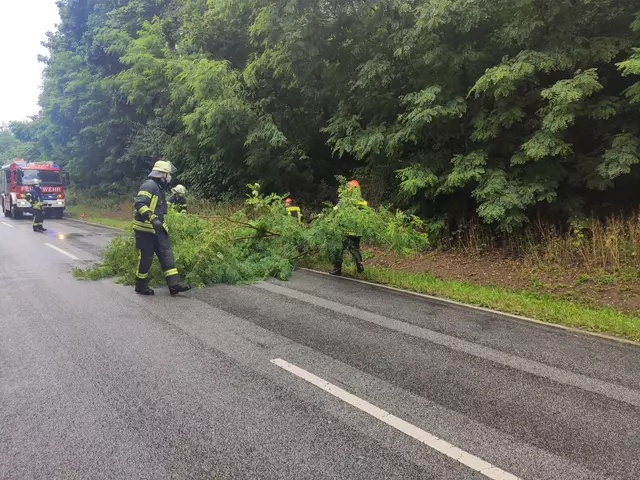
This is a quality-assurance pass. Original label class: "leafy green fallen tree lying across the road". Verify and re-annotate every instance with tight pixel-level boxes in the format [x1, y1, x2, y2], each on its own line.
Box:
[74, 179, 428, 286]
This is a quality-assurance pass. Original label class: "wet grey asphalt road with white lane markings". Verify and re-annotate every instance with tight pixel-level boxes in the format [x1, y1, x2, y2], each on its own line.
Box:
[0, 218, 640, 480]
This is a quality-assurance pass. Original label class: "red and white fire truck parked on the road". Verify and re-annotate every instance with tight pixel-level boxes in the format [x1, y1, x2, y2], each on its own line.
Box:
[0, 158, 69, 219]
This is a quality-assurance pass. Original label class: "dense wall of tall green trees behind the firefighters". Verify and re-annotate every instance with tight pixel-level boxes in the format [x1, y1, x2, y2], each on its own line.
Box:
[21, 0, 640, 232]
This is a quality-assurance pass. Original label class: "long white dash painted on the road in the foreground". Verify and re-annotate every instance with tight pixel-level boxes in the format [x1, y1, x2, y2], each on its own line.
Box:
[271, 358, 520, 480]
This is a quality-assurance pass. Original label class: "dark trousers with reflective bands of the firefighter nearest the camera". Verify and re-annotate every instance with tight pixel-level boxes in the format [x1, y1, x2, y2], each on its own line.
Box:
[135, 230, 180, 287]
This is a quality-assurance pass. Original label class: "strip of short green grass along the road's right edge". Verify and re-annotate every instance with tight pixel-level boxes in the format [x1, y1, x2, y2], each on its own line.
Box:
[69, 205, 640, 341]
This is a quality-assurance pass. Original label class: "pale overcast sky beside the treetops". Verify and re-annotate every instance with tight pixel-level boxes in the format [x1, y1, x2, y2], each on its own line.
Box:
[0, 0, 60, 124]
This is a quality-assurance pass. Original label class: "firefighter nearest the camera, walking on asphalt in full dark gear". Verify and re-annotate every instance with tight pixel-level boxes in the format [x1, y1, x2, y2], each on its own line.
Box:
[133, 161, 191, 295]
